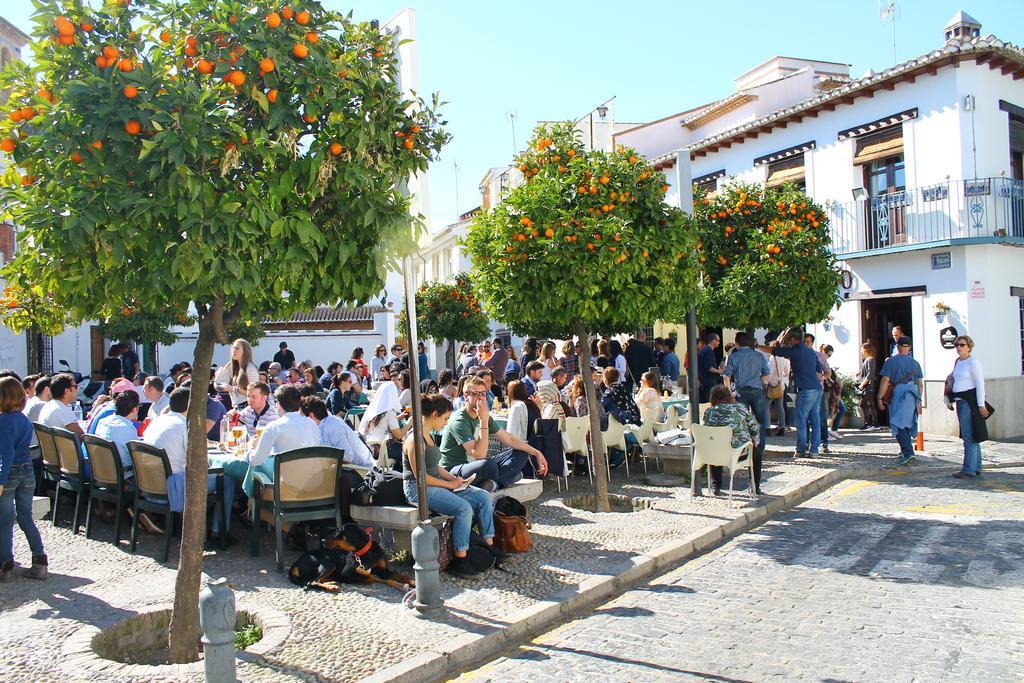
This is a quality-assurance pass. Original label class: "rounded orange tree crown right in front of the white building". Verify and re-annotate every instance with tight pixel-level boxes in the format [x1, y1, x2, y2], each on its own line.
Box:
[693, 183, 840, 330]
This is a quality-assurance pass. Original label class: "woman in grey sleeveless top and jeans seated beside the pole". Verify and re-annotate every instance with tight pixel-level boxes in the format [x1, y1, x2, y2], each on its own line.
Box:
[401, 395, 505, 579]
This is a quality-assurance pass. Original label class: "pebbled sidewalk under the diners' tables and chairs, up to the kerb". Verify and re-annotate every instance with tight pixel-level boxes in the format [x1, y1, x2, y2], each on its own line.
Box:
[0, 432, 1024, 683]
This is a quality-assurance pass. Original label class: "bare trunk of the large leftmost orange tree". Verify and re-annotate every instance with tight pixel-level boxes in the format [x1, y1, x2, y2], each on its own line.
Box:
[167, 310, 219, 664]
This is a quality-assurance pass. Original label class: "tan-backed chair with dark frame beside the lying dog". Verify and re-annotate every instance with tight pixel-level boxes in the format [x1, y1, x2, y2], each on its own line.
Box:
[250, 445, 344, 571]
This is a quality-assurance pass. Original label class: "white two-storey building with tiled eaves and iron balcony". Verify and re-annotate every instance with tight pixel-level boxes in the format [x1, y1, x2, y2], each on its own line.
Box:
[616, 12, 1024, 438]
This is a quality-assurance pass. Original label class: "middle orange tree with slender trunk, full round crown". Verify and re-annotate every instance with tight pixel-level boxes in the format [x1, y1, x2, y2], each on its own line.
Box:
[465, 123, 697, 511]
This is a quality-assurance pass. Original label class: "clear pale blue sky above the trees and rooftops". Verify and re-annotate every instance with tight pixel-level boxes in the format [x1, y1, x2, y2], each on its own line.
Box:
[0, 0, 1024, 229]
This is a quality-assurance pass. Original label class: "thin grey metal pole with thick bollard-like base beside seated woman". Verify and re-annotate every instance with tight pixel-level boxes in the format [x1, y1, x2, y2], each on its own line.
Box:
[401, 256, 444, 616]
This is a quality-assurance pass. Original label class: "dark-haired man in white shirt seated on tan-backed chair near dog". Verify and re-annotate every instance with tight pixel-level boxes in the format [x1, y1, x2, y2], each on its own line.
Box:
[224, 384, 321, 498]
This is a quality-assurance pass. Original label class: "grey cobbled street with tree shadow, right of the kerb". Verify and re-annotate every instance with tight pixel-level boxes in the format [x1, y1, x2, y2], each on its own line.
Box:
[459, 469, 1024, 682]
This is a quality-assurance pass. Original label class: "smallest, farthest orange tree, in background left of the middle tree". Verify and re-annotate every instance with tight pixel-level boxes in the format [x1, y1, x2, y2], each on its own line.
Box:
[398, 272, 490, 368]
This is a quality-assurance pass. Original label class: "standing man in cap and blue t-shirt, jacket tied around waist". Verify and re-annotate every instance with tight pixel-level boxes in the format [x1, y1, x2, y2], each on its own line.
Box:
[879, 335, 925, 465]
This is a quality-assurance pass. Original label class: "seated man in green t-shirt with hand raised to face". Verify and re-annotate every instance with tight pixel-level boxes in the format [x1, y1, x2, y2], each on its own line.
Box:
[440, 377, 548, 490]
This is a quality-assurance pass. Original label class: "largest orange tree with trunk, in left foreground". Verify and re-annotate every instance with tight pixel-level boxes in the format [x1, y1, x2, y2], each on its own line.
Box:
[0, 0, 446, 661]
